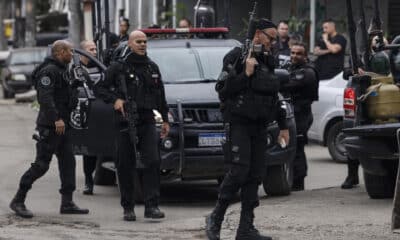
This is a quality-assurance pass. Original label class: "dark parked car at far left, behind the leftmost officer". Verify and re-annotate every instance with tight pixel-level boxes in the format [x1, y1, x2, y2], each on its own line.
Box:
[0, 47, 47, 98]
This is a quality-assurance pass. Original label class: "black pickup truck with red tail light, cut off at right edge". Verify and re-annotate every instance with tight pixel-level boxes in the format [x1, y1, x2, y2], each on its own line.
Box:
[343, 76, 400, 198]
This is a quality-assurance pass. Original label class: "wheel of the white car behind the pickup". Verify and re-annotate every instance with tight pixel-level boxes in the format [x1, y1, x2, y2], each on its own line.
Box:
[327, 121, 347, 163]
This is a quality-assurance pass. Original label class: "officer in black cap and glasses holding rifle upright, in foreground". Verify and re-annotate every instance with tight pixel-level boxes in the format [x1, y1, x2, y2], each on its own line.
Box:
[206, 19, 289, 240]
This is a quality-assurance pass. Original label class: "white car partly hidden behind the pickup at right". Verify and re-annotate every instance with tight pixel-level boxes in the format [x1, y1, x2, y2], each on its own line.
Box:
[308, 72, 347, 162]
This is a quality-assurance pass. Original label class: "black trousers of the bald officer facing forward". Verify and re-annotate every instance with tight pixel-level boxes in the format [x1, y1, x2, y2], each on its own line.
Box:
[116, 123, 160, 209]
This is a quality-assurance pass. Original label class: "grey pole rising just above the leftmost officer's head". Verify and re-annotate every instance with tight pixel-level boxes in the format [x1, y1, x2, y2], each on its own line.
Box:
[68, 0, 83, 47]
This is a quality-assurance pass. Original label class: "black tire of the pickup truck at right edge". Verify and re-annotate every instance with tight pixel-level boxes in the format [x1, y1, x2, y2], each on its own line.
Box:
[364, 162, 397, 199]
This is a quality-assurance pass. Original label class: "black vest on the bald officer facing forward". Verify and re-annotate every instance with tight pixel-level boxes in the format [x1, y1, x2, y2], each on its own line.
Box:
[120, 62, 161, 111]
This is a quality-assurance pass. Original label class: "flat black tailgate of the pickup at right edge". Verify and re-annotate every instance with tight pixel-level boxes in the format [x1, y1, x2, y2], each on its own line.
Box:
[343, 123, 400, 137]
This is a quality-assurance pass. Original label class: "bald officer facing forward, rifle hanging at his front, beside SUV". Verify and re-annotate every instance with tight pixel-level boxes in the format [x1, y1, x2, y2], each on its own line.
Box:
[97, 31, 170, 221]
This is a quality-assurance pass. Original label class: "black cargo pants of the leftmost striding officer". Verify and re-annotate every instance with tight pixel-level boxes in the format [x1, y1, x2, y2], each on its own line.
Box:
[19, 127, 76, 195]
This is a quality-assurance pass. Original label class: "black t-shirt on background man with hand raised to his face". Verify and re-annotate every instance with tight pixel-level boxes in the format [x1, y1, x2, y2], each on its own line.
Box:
[316, 34, 347, 79]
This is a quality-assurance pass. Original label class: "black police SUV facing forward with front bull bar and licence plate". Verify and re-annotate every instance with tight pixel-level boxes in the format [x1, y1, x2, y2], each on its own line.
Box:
[73, 29, 296, 199]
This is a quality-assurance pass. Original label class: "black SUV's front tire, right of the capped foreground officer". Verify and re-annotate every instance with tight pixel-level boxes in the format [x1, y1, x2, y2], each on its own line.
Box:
[263, 162, 293, 196]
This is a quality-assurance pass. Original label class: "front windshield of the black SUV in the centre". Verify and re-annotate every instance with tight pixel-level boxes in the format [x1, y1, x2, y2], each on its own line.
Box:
[148, 47, 232, 83]
